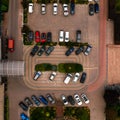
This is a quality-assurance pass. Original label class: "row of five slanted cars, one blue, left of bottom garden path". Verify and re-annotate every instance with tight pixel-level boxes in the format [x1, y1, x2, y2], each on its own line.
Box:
[19, 93, 56, 111]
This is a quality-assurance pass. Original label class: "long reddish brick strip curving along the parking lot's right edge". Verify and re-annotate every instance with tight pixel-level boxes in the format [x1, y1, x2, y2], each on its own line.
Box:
[88, 0, 107, 92]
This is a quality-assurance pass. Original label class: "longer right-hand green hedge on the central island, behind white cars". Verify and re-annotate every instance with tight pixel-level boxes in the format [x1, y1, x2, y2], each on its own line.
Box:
[58, 63, 83, 73]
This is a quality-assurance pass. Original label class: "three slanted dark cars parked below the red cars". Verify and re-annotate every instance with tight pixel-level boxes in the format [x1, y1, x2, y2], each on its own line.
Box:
[30, 45, 54, 56]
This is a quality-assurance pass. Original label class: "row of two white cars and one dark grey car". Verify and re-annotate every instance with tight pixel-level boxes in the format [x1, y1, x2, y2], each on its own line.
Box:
[59, 30, 81, 43]
